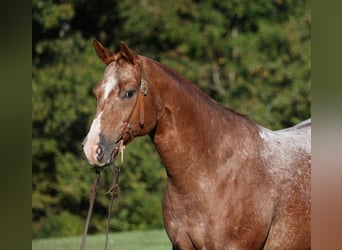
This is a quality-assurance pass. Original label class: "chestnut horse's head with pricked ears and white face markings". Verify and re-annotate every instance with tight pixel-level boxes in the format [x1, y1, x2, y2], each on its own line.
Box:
[82, 40, 156, 166]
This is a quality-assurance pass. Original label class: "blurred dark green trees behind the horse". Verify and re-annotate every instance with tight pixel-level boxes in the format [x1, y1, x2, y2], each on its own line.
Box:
[32, 0, 311, 238]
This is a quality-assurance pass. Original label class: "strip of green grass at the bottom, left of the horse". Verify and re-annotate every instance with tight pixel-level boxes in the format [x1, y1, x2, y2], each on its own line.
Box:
[32, 230, 172, 250]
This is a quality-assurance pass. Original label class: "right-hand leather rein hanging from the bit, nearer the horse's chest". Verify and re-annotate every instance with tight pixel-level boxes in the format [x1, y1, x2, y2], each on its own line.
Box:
[105, 140, 125, 250]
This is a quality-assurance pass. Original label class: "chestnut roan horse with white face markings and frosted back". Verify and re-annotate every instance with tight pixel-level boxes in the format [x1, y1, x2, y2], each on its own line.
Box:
[82, 40, 311, 250]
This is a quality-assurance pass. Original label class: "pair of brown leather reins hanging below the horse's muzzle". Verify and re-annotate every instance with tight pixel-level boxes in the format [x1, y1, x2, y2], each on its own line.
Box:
[80, 140, 125, 250]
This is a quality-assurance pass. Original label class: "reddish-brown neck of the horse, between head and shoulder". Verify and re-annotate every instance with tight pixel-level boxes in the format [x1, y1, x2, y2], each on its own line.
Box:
[142, 56, 255, 188]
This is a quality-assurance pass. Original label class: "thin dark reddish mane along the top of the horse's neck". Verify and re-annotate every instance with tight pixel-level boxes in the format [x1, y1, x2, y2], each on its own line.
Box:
[147, 58, 251, 121]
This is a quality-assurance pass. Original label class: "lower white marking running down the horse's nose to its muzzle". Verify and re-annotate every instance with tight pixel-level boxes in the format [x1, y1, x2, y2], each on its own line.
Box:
[83, 111, 102, 164]
